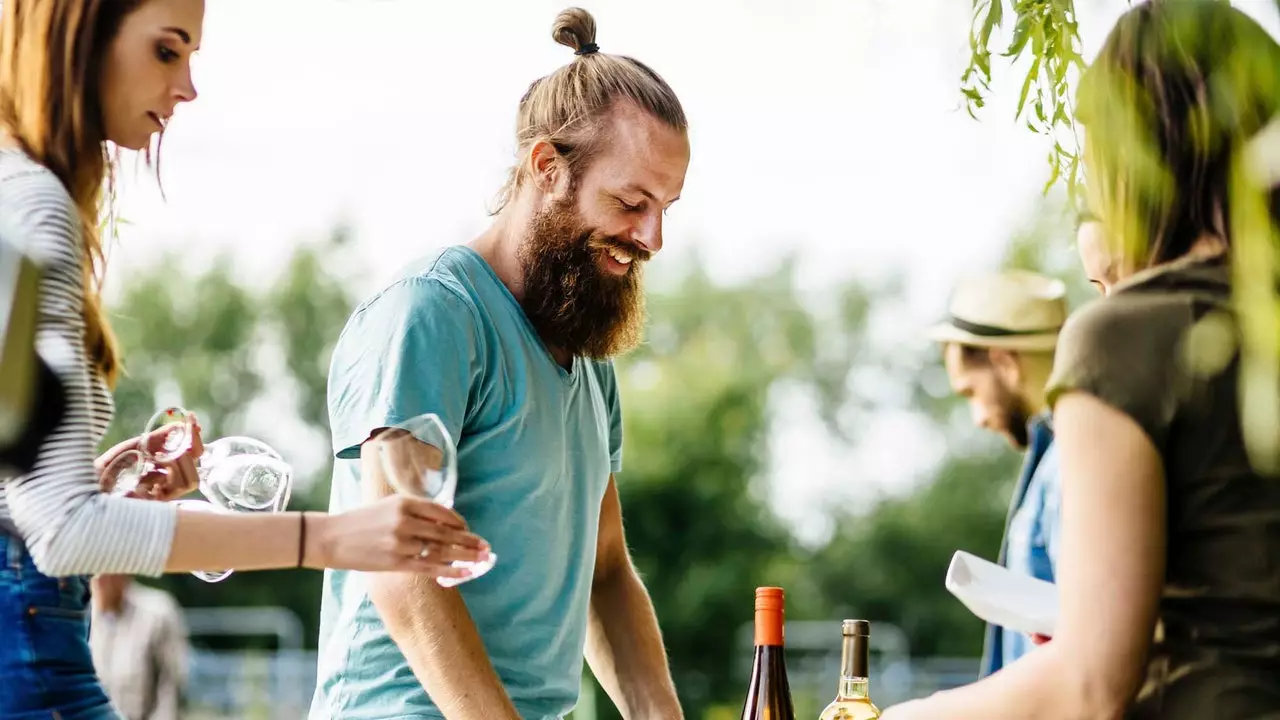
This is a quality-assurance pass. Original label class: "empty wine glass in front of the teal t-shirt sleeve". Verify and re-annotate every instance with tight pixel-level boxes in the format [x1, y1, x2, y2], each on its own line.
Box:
[378, 413, 498, 588]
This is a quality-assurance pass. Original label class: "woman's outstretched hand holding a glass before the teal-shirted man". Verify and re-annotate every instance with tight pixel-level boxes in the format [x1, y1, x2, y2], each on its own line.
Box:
[302, 495, 492, 579]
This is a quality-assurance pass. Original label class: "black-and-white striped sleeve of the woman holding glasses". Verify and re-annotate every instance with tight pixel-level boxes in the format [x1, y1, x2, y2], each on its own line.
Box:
[0, 154, 178, 577]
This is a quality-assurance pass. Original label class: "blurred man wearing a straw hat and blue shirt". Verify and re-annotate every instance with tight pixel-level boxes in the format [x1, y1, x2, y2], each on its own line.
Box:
[929, 270, 1068, 676]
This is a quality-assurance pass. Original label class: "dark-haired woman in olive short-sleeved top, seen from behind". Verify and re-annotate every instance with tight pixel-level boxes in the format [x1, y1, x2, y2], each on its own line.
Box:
[884, 0, 1280, 720]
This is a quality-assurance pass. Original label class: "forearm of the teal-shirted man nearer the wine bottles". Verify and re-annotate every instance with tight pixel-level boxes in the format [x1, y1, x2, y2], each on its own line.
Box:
[586, 564, 684, 720]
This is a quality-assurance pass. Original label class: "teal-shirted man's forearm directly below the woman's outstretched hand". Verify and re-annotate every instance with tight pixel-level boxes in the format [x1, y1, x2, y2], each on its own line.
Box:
[370, 573, 520, 720]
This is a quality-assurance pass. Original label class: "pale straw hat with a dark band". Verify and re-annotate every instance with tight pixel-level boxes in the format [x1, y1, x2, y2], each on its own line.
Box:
[928, 270, 1066, 351]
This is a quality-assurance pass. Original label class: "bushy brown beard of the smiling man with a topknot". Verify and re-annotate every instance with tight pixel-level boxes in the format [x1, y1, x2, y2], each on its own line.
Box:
[520, 197, 649, 360]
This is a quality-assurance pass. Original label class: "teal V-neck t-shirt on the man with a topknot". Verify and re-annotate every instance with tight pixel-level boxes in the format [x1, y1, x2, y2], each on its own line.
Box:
[311, 246, 622, 720]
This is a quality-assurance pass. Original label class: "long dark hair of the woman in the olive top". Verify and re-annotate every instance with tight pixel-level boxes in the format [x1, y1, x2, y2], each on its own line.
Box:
[1076, 0, 1280, 272]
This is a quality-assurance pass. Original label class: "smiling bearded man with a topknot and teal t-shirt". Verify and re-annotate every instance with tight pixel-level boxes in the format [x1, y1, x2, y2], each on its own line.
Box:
[311, 8, 689, 720]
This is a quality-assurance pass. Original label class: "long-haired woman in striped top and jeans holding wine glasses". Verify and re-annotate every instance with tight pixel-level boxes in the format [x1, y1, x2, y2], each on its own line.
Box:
[0, 0, 488, 720]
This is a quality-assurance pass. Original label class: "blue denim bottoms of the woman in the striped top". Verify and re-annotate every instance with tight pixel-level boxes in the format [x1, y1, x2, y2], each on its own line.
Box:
[0, 532, 124, 720]
